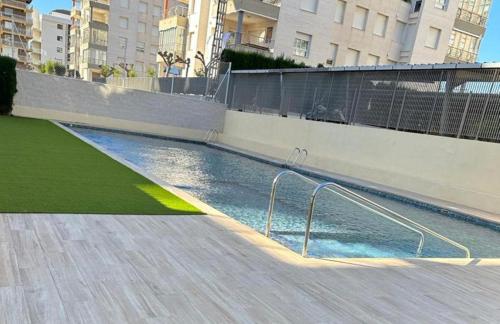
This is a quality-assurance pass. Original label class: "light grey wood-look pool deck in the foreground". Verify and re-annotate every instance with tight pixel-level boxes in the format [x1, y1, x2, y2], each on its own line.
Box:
[0, 214, 500, 323]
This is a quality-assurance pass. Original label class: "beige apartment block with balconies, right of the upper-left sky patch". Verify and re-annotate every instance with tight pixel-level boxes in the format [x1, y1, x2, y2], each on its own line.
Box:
[69, 0, 163, 80]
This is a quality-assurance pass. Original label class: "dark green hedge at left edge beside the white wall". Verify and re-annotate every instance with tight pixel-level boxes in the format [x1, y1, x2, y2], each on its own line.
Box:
[0, 56, 17, 115]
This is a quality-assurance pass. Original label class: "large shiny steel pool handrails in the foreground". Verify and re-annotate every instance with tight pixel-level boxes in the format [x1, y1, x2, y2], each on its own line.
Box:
[265, 170, 471, 258]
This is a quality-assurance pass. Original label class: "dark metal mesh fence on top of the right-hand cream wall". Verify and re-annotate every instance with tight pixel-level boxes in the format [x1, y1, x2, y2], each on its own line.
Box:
[229, 67, 500, 142]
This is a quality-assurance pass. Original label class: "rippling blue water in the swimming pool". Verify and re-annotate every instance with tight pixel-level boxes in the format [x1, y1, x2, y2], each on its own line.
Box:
[73, 127, 500, 258]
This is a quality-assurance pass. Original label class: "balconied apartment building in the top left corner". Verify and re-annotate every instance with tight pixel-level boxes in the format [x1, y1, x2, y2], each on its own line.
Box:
[0, 0, 32, 67]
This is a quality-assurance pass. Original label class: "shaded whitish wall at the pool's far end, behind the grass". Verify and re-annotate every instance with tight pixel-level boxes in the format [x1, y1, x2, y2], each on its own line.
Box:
[13, 70, 225, 140]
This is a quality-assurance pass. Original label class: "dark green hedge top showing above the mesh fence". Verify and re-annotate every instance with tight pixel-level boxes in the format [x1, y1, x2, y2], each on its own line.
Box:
[221, 49, 307, 70]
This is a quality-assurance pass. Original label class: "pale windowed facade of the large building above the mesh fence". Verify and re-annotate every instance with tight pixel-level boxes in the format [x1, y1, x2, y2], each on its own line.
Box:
[272, 0, 491, 66]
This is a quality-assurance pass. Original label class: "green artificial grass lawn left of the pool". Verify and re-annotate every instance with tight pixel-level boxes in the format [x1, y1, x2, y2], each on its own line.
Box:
[0, 116, 202, 215]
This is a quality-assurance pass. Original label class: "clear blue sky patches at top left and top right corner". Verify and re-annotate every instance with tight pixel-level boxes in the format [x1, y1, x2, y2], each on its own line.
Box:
[32, 0, 500, 62]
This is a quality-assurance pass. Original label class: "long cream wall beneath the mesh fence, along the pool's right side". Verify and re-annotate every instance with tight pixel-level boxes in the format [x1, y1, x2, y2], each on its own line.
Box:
[219, 111, 500, 219]
